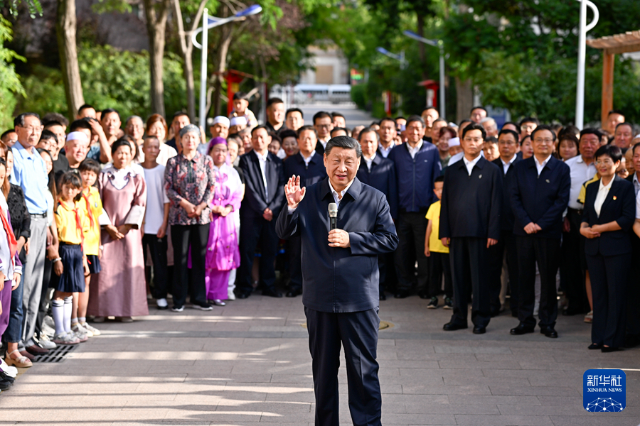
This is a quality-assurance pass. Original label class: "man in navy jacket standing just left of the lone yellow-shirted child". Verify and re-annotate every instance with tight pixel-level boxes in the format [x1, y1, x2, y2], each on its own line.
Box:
[388, 116, 442, 298]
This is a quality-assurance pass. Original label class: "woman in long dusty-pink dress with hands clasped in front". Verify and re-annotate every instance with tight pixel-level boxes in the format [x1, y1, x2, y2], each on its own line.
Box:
[88, 137, 149, 322]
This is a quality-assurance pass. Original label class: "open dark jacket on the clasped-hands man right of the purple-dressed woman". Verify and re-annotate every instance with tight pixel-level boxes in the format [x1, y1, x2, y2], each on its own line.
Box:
[240, 151, 286, 218]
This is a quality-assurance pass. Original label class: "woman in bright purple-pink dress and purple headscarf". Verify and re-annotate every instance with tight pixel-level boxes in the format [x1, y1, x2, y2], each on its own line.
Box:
[205, 137, 242, 306]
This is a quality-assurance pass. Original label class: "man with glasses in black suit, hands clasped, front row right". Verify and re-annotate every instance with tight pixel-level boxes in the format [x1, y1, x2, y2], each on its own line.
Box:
[510, 125, 571, 338]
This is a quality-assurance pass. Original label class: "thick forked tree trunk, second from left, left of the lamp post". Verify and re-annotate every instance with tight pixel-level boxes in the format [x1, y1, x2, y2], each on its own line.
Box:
[144, 0, 170, 116]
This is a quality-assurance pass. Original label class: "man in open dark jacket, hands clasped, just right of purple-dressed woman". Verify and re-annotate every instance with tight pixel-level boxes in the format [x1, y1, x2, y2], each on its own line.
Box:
[235, 125, 285, 299]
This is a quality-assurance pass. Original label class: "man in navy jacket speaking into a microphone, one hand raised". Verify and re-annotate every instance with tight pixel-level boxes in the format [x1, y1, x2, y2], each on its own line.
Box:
[277, 136, 398, 426]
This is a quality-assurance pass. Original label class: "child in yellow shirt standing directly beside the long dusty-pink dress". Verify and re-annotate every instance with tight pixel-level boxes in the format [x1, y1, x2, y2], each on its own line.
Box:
[71, 159, 102, 337]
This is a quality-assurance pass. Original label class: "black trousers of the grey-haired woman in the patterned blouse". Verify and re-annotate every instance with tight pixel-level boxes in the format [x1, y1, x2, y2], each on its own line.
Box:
[171, 224, 210, 307]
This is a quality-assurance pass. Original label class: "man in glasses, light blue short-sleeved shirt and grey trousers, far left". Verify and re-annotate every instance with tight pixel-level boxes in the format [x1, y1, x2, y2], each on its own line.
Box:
[11, 112, 49, 354]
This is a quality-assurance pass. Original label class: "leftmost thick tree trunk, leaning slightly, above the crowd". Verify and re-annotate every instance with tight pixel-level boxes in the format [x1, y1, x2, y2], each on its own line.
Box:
[56, 0, 84, 120]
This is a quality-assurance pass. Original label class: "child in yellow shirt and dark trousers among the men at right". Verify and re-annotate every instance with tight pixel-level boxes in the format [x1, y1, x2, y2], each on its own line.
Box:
[424, 176, 453, 309]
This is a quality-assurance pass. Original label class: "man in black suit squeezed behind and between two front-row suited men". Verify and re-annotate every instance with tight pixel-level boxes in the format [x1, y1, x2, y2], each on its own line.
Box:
[489, 129, 520, 317]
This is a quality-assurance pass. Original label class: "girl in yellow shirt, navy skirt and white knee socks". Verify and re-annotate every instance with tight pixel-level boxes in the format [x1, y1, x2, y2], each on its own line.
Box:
[51, 172, 89, 345]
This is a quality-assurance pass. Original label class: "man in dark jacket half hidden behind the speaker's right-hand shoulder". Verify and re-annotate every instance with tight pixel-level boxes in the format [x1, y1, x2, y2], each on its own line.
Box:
[357, 127, 398, 300]
